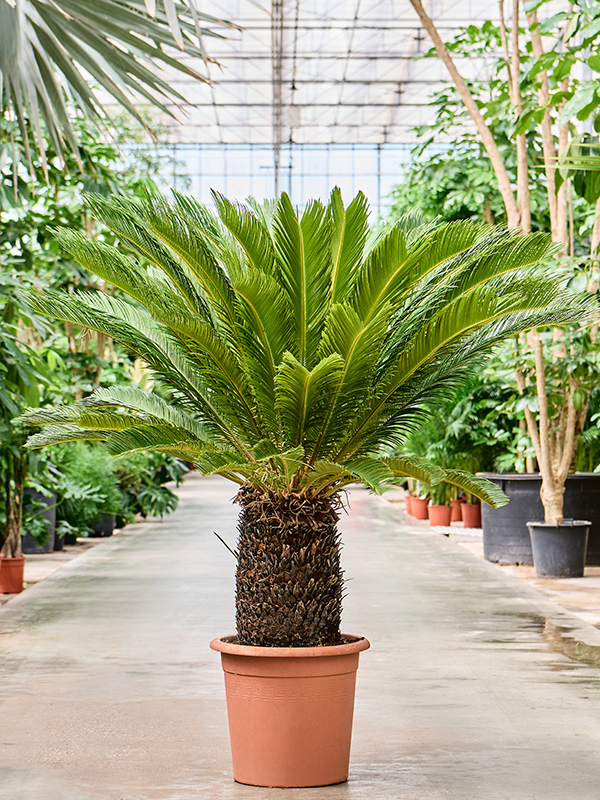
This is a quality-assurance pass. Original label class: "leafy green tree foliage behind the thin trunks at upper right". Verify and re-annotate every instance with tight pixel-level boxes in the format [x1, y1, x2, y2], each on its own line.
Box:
[389, 10, 600, 244]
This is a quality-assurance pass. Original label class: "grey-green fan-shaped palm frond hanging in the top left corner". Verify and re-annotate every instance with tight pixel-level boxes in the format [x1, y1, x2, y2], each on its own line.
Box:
[0, 0, 231, 167]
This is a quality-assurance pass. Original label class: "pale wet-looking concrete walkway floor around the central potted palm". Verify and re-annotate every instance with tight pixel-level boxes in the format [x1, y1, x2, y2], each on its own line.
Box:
[0, 476, 600, 800]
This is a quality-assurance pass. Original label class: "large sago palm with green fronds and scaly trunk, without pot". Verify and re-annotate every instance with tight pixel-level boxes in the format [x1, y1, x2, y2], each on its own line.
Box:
[21, 189, 589, 646]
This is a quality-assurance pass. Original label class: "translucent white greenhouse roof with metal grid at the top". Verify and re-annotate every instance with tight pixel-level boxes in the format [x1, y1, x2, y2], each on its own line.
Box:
[166, 0, 498, 147]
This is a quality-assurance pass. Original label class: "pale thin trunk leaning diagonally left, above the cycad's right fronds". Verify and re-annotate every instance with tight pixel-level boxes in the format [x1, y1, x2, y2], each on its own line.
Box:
[410, 0, 521, 227]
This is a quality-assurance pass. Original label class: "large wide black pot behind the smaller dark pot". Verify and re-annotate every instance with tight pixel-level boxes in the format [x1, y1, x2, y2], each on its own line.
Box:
[479, 472, 600, 567]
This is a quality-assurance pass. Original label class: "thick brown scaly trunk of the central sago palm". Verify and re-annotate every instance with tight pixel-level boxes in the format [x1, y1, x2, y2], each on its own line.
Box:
[236, 487, 344, 647]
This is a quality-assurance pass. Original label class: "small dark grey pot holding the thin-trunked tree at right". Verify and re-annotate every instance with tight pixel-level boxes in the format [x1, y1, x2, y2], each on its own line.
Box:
[527, 519, 590, 578]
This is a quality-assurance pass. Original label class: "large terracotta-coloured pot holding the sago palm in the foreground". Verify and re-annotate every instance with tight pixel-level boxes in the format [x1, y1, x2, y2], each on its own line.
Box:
[210, 635, 370, 788]
